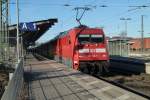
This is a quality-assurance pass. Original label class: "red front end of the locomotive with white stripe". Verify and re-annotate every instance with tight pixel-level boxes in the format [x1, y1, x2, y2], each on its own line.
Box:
[76, 29, 109, 74]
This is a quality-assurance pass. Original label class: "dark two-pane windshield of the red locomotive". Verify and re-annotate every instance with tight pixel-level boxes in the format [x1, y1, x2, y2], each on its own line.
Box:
[78, 34, 104, 44]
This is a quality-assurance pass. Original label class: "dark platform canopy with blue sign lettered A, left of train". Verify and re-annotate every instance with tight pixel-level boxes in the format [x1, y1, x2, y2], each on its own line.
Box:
[9, 19, 58, 47]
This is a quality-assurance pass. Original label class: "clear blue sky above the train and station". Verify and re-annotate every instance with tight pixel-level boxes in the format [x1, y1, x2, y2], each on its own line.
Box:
[10, 0, 150, 42]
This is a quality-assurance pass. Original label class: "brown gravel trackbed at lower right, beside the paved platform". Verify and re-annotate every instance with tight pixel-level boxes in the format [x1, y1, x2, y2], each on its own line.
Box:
[103, 73, 150, 96]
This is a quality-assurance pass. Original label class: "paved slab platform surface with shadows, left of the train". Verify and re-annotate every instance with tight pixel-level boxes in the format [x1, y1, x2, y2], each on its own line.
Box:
[25, 56, 146, 100]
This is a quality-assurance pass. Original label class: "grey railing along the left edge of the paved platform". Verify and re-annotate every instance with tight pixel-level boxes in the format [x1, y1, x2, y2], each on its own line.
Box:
[1, 59, 24, 100]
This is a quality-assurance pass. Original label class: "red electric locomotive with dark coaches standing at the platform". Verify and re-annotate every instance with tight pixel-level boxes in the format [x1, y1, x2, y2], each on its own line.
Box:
[34, 25, 109, 74]
